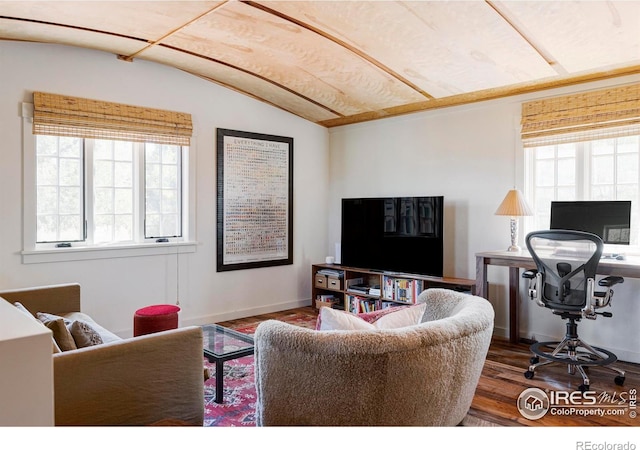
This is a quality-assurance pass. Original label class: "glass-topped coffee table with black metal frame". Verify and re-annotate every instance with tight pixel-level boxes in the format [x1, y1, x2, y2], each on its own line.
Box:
[202, 325, 254, 403]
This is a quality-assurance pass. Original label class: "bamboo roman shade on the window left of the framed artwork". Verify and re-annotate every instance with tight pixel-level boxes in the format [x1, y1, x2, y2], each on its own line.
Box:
[33, 92, 192, 146]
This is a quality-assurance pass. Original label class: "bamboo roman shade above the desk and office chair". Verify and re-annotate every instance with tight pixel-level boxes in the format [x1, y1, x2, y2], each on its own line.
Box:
[522, 84, 640, 147]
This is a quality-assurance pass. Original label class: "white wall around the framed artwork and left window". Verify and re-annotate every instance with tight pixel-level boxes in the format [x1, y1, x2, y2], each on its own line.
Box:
[0, 42, 329, 336]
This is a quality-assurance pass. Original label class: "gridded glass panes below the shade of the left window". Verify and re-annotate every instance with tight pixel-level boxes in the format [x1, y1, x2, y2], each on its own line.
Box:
[36, 135, 185, 245]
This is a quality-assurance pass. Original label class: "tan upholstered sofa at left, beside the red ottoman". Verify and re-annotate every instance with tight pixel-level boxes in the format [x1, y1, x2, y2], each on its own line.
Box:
[0, 284, 204, 426]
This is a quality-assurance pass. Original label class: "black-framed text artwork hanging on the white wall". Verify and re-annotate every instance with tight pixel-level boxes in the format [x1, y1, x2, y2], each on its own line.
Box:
[216, 128, 293, 272]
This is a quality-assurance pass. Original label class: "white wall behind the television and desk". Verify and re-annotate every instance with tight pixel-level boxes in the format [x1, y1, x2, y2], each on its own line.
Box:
[327, 76, 640, 362]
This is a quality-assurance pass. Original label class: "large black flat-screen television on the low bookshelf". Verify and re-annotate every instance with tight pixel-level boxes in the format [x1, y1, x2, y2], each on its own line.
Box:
[341, 196, 444, 277]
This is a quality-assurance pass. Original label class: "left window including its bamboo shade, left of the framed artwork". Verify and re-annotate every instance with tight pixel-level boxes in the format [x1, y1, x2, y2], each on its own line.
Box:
[22, 92, 195, 263]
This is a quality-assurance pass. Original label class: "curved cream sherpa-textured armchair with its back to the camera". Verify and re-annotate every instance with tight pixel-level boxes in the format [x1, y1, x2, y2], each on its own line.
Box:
[255, 289, 494, 426]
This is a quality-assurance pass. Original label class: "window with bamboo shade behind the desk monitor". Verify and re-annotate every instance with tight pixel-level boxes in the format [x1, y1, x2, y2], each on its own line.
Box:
[522, 84, 640, 246]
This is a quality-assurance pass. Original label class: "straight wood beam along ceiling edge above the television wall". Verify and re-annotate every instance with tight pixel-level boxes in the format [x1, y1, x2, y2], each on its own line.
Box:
[318, 65, 640, 128]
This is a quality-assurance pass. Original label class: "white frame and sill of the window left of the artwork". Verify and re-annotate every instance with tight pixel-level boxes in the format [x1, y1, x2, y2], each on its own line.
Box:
[21, 102, 197, 264]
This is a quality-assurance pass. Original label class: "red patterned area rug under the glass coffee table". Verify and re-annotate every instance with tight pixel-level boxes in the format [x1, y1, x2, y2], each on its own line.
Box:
[204, 313, 316, 427]
